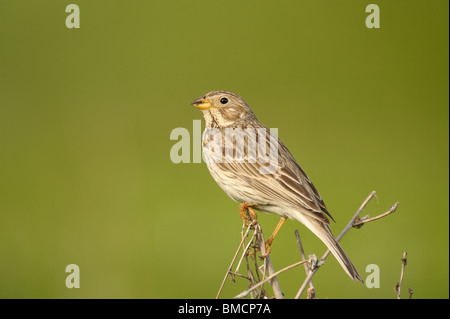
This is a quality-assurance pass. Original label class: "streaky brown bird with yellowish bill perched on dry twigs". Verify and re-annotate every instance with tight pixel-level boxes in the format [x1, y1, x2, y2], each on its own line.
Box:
[191, 90, 363, 282]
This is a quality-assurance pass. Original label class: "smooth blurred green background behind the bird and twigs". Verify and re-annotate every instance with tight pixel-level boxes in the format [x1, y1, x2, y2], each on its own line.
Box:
[0, 0, 449, 298]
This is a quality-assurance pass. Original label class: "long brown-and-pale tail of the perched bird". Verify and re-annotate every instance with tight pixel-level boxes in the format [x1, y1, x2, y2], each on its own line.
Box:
[296, 213, 364, 282]
